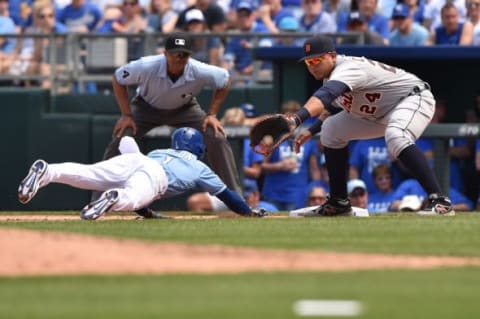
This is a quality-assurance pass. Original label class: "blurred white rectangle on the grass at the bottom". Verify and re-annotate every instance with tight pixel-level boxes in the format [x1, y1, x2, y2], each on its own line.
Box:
[293, 299, 362, 317]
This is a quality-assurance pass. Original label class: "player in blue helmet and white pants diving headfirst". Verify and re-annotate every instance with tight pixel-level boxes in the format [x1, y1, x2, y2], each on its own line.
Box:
[18, 127, 265, 219]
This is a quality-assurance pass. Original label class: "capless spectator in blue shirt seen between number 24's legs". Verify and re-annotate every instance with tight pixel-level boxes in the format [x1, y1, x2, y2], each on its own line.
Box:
[368, 164, 394, 213]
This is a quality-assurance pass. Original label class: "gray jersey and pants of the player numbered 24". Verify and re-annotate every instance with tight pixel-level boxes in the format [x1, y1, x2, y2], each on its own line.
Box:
[321, 55, 435, 157]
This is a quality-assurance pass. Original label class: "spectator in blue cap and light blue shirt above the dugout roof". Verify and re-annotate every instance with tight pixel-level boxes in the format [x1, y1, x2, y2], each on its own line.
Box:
[390, 4, 428, 46]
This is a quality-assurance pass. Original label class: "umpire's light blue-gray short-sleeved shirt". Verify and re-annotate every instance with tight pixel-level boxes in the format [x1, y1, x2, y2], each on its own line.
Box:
[115, 55, 229, 110]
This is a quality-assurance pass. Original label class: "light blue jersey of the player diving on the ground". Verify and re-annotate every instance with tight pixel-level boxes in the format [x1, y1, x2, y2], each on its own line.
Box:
[147, 149, 227, 197]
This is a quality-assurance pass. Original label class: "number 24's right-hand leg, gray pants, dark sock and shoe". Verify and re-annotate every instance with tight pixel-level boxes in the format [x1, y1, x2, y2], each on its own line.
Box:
[385, 90, 454, 215]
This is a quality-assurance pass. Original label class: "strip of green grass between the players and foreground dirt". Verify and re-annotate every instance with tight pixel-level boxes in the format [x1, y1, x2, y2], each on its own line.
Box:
[0, 213, 480, 257]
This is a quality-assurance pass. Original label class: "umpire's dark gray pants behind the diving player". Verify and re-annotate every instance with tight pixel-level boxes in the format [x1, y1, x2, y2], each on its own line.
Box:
[103, 97, 242, 194]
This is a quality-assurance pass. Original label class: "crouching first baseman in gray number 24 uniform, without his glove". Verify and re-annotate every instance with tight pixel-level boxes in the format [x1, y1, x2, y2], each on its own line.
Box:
[289, 36, 455, 216]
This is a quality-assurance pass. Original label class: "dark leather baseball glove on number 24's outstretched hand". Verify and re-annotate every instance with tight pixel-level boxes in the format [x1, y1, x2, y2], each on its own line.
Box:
[250, 114, 296, 156]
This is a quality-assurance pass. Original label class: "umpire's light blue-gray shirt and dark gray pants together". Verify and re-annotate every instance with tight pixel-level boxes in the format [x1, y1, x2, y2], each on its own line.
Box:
[104, 55, 241, 193]
